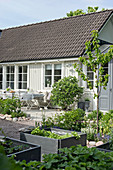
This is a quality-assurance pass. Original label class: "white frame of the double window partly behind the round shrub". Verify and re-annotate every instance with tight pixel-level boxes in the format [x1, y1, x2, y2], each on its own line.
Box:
[43, 63, 63, 89]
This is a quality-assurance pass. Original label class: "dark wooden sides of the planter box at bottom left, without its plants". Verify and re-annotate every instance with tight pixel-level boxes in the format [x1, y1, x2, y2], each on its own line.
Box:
[0, 137, 41, 162]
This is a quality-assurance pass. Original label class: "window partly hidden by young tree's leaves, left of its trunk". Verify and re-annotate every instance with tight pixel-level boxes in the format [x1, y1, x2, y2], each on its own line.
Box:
[87, 67, 94, 89]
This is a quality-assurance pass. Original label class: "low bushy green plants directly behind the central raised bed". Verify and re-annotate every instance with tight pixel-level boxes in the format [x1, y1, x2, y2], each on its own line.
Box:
[42, 108, 85, 131]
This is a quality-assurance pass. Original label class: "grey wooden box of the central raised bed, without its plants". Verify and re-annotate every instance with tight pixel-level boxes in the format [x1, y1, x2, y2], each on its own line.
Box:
[20, 128, 86, 157]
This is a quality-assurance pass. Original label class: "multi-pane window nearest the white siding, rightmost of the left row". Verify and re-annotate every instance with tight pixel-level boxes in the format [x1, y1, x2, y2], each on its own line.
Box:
[18, 66, 27, 89]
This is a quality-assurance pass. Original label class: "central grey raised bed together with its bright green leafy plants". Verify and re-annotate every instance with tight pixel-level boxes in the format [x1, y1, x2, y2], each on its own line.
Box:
[20, 127, 86, 157]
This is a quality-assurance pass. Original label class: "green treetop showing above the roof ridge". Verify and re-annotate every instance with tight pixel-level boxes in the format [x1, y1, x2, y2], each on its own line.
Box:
[66, 6, 105, 17]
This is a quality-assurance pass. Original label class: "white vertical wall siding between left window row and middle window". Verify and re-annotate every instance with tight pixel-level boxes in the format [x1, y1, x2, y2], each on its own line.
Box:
[29, 64, 42, 91]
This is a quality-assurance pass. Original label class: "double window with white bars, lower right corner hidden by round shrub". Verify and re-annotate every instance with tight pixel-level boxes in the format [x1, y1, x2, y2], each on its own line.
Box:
[45, 64, 61, 87]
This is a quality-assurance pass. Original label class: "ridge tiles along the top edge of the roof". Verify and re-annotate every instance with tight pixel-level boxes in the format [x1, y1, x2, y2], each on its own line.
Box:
[1, 9, 113, 31]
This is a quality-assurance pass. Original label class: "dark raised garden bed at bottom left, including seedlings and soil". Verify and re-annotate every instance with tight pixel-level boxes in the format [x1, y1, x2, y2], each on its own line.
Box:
[0, 136, 41, 162]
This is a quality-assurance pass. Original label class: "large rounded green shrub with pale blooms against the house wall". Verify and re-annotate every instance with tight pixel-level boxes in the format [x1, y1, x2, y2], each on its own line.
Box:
[51, 76, 83, 109]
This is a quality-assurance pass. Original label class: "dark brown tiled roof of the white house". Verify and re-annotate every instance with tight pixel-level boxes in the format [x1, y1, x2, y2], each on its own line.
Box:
[0, 10, 113, 62]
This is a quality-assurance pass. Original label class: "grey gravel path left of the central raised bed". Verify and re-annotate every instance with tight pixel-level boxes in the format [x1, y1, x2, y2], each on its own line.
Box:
[0, 119, 35, 139]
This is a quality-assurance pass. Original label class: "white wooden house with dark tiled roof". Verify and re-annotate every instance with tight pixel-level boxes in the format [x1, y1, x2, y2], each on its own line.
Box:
[0, 10, 113, 110]
